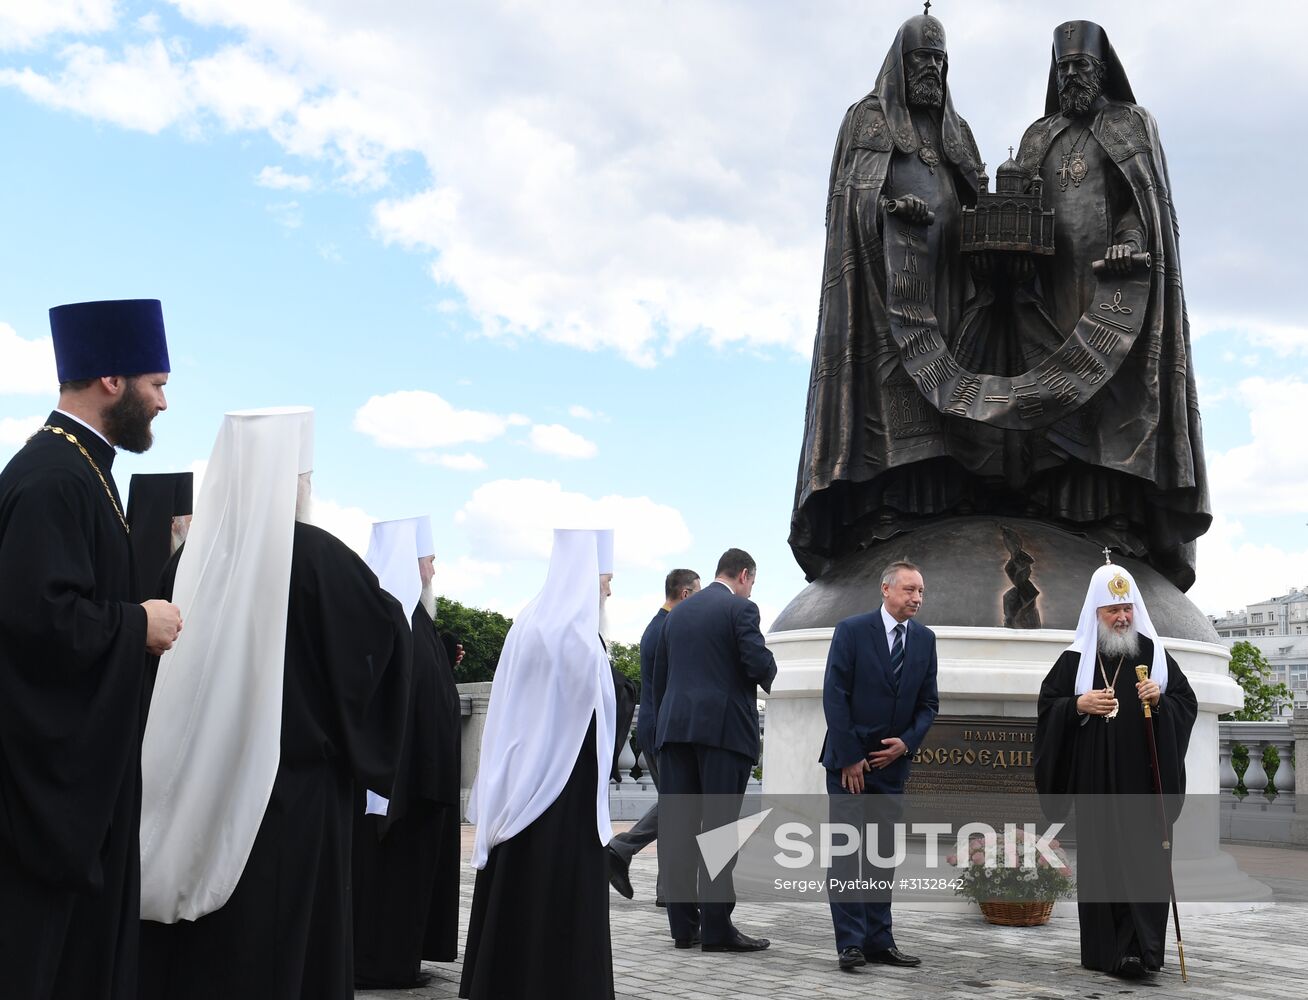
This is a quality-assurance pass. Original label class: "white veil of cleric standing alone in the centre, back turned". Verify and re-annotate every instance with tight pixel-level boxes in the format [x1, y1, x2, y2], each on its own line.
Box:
[468, 528, 617, 868]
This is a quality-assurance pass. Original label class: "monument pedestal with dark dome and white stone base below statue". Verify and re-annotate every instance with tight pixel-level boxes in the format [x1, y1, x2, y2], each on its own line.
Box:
[763, 518, 1271, 912]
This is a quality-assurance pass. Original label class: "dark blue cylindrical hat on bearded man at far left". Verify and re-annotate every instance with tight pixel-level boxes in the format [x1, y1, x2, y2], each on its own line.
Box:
[50, 298, 171, 384]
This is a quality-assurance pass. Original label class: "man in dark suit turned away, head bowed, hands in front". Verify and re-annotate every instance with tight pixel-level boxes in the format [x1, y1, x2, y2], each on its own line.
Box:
[654, 549, 777, 952]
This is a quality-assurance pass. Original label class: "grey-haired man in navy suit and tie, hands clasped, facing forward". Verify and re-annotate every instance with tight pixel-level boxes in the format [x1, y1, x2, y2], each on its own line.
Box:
[821, 562, 940, 970]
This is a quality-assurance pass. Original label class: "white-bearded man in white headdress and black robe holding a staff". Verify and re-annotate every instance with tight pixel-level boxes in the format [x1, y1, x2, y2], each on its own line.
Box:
[1035, 563, 1198, 979]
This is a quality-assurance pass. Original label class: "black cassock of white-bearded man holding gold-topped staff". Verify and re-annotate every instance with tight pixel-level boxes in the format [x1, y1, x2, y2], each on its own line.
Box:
[1035, 637, 1198, 971]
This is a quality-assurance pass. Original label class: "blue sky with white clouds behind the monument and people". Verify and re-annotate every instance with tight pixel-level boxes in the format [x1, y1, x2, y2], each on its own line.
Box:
[0, 0, 1308, 638]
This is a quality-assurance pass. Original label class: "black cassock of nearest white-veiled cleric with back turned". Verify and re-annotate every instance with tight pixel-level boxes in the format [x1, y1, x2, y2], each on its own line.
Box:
[141, 523, 411, 1000]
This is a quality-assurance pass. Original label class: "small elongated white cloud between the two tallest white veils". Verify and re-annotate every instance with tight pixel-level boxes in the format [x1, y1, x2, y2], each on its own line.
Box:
[354, 390, 530, 448]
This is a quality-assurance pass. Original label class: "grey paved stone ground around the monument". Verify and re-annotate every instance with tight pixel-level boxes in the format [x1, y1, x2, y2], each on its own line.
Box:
[356, 827, 1308, 1000]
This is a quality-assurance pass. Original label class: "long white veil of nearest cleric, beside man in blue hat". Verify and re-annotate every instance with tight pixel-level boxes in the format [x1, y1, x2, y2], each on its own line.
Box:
[141, 407, 313, 923]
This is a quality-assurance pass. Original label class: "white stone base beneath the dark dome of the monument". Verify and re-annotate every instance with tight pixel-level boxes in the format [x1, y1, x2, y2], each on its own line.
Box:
[763, 626, 1271, 915]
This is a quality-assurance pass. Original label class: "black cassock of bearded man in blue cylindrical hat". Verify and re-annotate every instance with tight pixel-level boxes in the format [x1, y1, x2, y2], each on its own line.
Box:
[0, 413, 146, 1000]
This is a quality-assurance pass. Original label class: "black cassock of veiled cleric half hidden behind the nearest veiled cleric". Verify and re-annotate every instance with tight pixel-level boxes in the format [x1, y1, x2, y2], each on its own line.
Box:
[354, 604, 462, 988]
